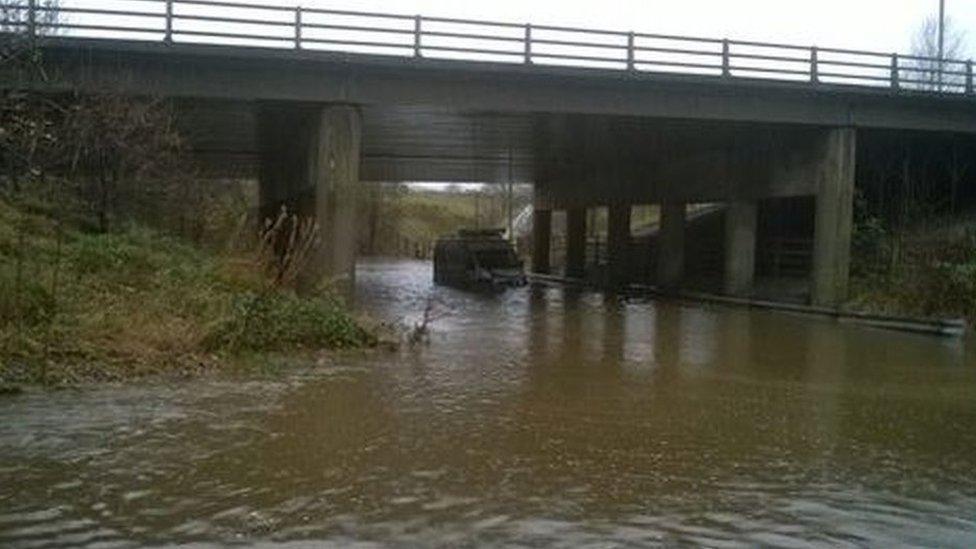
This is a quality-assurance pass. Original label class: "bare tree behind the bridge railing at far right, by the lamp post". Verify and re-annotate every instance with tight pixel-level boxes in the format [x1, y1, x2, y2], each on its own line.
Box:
[901, 16, 966, 91]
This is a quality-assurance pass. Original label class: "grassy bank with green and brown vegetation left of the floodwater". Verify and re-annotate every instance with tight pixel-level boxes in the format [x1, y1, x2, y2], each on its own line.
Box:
[0, 199, 376, 385]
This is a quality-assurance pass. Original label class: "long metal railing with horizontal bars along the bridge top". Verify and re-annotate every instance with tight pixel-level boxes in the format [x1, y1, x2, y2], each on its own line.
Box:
[0, 0, 976, 96]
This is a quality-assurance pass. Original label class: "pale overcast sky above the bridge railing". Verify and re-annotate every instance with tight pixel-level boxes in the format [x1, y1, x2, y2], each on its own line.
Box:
[278, 0, 976, 58]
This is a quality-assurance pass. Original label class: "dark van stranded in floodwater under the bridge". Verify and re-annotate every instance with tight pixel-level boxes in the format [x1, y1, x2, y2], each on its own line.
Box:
[434, 229, 526, 289]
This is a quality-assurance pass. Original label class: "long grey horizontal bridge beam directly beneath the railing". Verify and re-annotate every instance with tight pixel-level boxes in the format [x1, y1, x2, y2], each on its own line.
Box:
[38, 36, 976, 134]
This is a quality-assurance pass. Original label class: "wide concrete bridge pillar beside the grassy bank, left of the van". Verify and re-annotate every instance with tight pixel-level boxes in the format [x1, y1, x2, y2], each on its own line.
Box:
[258, 103, 362, 287]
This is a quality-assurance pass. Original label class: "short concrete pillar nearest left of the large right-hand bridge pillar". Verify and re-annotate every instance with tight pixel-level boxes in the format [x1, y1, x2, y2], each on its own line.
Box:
[725, 201, 759, 296]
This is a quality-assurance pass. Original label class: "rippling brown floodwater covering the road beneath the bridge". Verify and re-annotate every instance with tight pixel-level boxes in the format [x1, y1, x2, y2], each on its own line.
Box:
[0, 262, 976, 547]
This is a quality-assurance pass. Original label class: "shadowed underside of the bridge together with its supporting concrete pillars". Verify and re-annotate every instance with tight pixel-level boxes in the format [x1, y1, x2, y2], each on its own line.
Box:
[172, 101, 872, 305]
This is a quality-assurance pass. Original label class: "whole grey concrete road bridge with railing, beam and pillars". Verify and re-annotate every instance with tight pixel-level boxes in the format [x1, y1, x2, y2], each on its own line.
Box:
[7, 1, 976, 305]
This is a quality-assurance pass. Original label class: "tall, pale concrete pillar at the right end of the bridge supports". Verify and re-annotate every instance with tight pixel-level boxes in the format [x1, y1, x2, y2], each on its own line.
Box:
[810, 128, 857, 306]
